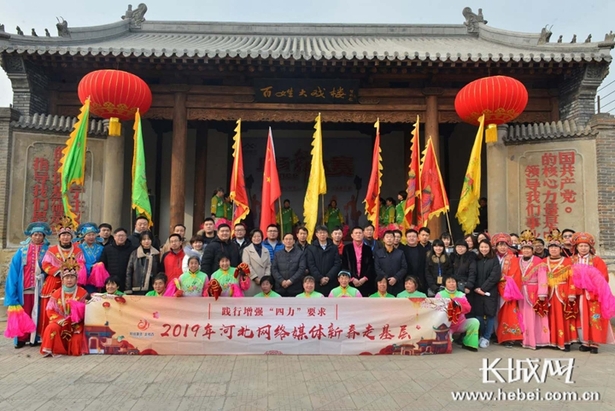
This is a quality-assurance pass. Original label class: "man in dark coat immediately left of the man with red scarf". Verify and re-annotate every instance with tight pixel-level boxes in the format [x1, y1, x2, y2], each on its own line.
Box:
[304, 225, 342, 297]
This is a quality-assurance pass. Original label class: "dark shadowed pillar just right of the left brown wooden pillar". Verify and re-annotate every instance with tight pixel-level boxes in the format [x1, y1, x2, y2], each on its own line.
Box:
[192, 121, 209, 233]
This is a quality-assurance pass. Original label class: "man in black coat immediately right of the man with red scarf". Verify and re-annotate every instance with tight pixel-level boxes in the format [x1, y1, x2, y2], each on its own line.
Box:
[374, 230, 408, 296]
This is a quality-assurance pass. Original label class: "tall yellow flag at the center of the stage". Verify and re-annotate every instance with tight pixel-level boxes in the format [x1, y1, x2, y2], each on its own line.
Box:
[303, 113, 327, 243]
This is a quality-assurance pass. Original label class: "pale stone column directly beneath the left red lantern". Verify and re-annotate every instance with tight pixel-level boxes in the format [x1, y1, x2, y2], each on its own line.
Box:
[102, 130, 125, 229]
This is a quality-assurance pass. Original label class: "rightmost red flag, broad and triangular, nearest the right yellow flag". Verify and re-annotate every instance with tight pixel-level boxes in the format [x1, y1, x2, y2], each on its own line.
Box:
[420, 137, 449, 225]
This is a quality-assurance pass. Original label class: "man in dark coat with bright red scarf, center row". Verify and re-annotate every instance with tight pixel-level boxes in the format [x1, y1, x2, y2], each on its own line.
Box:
[342, 227, 376, 297]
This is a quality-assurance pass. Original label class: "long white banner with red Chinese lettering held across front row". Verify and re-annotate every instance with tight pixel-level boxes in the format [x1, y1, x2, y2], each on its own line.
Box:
[85, 296, 451, 355]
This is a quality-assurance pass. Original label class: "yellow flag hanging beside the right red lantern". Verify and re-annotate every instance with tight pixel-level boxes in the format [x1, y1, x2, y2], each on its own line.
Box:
[455, 115, 485, 234]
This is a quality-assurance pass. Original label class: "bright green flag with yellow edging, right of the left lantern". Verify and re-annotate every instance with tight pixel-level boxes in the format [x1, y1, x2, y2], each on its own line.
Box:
[132, 110, 152, 227]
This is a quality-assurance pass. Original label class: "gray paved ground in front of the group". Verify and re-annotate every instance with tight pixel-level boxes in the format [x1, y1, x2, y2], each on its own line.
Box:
[0, 323, 615, 411]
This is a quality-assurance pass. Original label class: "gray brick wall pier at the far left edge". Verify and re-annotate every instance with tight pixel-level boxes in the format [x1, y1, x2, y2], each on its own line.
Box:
[0, 107, 19, 248]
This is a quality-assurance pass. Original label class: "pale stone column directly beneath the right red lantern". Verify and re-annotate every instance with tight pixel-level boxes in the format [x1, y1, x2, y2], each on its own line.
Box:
[483, 124, 510, 233]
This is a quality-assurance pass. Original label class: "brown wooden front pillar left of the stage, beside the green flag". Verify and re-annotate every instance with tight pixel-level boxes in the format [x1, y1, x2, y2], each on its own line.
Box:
[169, 92, 188, 232]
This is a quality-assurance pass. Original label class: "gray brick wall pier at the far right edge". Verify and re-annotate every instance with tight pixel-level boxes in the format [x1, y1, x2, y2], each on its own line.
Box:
[589, 114, 615, 253]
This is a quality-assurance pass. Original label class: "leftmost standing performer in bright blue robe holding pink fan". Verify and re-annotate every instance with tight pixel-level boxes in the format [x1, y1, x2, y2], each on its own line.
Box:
[4, 222, 51, 348]
